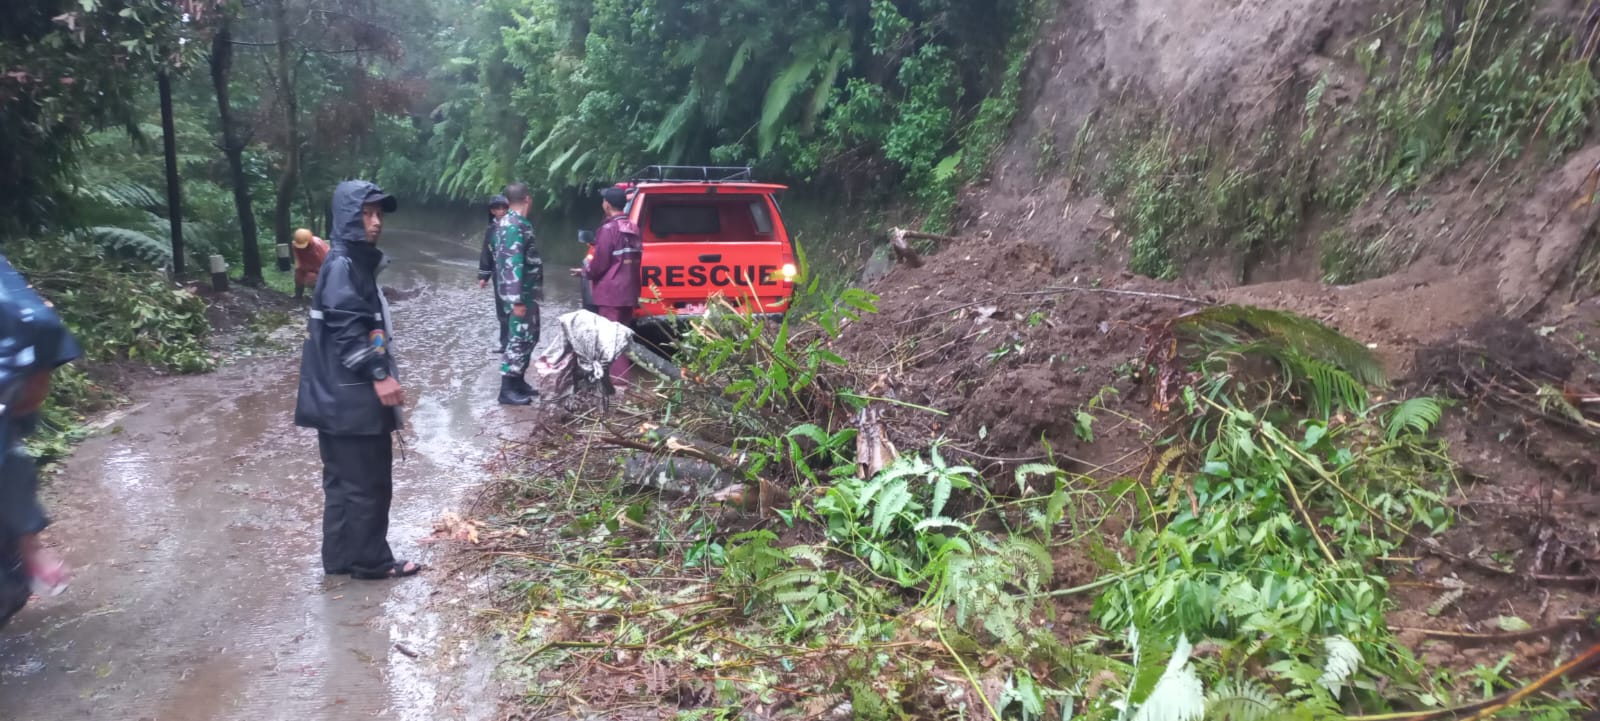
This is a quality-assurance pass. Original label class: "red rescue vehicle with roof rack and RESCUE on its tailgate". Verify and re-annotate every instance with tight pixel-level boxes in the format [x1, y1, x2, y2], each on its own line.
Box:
[582, 166, 798, 336]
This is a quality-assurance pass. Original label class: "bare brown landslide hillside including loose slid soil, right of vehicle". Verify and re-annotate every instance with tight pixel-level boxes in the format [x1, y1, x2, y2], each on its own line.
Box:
[843, 0, 1600, 700]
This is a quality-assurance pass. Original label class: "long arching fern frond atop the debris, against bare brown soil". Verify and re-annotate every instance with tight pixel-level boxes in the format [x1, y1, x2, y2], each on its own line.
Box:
[1173, 305, 1389, 387]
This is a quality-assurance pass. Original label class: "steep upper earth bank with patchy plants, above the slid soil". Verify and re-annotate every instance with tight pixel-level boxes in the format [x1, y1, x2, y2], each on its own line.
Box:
[963, 0, 1600, 326]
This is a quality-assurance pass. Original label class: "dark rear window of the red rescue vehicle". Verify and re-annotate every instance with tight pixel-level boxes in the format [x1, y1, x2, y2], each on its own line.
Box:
[640, 193, 776, 243]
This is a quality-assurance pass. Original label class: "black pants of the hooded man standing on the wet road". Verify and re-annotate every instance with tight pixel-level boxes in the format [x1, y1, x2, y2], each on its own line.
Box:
[317, 433, 395, 574]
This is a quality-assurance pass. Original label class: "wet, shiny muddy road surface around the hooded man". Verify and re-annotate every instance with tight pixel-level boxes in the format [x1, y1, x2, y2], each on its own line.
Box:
[0, 222, 578, 721]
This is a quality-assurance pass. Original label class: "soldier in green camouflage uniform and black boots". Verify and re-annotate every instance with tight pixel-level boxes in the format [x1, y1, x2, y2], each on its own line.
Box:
[494, 182, 544, 406]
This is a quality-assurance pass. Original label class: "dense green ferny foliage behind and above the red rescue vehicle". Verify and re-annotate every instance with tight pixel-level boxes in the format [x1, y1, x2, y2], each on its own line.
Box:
[384, 0, 1032, 222]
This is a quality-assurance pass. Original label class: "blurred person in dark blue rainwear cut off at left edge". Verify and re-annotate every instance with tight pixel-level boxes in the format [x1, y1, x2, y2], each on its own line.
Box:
[0, 257, 83, 625]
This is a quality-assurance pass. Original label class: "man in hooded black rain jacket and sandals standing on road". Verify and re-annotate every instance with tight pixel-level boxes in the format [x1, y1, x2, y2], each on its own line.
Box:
[294, 181, 422, 579]
